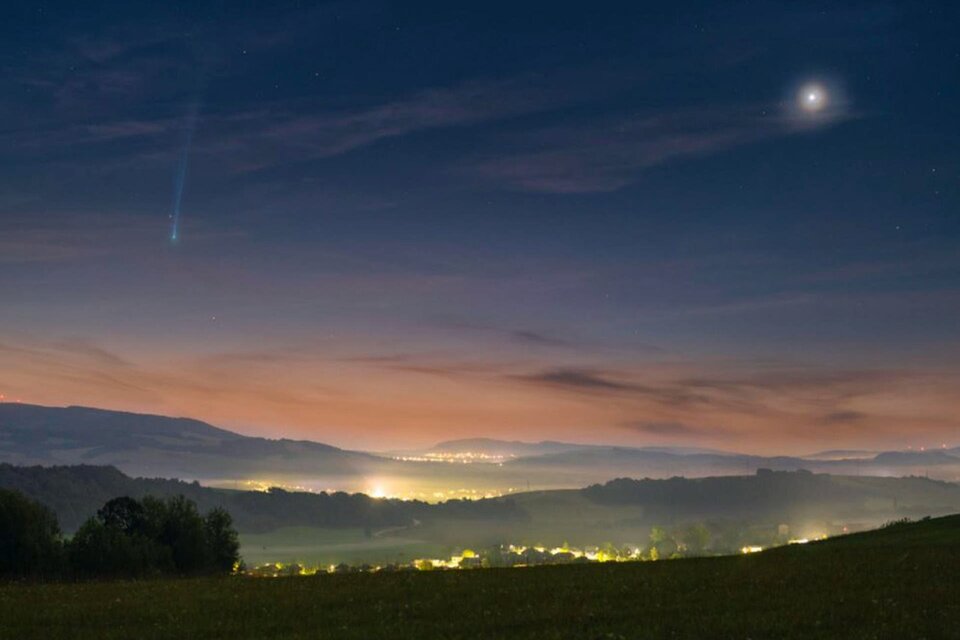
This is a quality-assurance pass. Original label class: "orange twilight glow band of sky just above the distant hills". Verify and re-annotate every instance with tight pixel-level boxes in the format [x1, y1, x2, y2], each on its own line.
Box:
[0, 342, 960, 454]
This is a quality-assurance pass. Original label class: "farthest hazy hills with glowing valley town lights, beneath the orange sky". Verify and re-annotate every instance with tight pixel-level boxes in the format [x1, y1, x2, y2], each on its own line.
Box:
[0, 403, 960, 490]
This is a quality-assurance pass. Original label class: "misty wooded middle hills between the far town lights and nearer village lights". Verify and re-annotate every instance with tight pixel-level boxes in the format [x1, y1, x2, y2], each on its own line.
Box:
[0, 464, 960, 546]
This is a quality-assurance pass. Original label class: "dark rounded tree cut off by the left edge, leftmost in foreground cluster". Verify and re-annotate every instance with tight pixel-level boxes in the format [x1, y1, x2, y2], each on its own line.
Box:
[0, 489, 63, 575]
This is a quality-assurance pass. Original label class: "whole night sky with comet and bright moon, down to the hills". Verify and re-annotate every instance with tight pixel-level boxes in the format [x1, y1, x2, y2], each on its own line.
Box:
[0, 1, 960, 453]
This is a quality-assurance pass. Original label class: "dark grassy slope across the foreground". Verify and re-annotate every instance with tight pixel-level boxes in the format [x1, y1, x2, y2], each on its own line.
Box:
[0, 516, 960, 640]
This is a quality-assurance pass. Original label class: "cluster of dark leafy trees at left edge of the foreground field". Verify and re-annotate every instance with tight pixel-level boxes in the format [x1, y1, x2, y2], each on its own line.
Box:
[0, 489, 240, 579]
